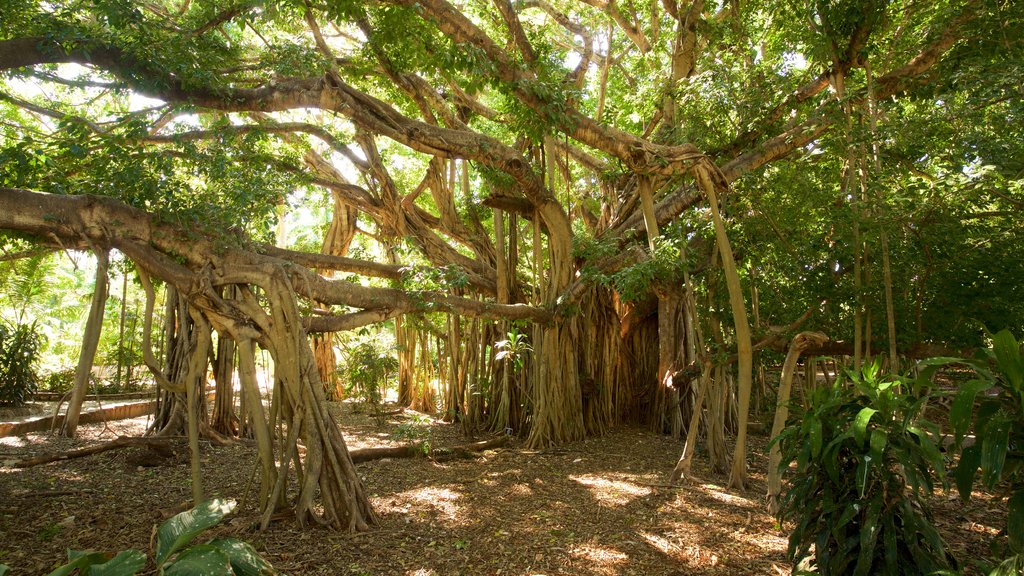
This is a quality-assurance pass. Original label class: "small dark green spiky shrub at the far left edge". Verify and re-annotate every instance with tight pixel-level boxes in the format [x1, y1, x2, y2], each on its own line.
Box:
[0, 322, 43, 406]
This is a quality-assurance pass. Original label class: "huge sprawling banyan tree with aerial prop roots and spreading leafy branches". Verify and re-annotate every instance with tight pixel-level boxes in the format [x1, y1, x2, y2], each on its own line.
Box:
[0, 0, 1017, 530]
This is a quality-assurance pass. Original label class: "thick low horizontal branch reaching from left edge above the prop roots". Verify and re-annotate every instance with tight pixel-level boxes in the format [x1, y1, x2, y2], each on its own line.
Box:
[0, 189, 554, 328]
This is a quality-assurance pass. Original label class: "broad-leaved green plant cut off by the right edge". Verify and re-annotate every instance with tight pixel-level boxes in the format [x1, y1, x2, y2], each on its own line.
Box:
[949, 330, 1024, 562]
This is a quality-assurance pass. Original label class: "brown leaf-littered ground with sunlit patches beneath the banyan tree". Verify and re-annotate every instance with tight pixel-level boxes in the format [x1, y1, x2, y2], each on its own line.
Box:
[0, 403, 1006, 576]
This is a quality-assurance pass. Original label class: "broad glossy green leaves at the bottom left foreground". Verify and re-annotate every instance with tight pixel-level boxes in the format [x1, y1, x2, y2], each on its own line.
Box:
[43, 498, 278, 576]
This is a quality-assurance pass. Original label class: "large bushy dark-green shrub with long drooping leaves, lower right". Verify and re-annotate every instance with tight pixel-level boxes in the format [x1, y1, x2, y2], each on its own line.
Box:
[773, 364, 951, 575]
